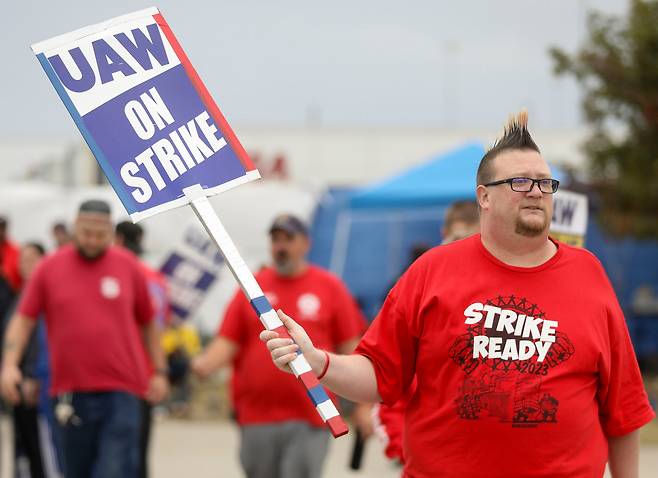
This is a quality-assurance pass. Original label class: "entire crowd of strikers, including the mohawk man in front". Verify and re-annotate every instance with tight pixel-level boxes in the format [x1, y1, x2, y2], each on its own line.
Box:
[0, 114, 655, 478]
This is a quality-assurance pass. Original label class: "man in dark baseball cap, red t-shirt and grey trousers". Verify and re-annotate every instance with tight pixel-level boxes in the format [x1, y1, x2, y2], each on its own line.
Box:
[192, 215, 366, 478]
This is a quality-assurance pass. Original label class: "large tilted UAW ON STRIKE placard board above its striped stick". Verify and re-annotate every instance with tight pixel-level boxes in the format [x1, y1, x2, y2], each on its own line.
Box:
[32, 8, 259, 221]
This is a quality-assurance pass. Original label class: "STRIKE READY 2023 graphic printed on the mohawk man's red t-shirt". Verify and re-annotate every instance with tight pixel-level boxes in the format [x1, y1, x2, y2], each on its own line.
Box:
[449, 295, 575, 427]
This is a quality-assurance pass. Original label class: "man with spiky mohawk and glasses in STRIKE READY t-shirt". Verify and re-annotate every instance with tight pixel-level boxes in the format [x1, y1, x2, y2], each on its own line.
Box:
[261, 112, 654, 478]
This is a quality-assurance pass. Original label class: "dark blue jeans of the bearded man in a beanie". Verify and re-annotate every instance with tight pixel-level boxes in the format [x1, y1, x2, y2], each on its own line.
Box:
[53, 392, 140, 478]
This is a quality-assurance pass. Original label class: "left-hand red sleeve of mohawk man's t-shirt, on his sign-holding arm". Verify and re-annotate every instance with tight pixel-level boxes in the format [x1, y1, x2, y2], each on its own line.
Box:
[355, 267, 421, 405]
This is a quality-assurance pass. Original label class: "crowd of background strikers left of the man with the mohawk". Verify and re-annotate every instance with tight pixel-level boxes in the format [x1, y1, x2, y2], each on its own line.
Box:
[0, 204, 372, 478]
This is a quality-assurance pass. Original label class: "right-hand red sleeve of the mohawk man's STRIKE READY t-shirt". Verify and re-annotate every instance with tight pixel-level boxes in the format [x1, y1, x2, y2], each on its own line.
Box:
[597, 278, 655, 436]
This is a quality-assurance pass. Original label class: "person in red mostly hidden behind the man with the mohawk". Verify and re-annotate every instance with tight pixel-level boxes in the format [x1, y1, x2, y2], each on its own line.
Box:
[372, 201, 480, 463]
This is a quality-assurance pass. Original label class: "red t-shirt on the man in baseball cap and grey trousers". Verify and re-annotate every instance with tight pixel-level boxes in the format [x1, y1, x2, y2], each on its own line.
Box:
[218, 265, 366, 427]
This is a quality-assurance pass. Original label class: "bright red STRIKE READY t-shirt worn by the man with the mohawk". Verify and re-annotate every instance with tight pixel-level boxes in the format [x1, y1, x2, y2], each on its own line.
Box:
[357, 234, 654, 478]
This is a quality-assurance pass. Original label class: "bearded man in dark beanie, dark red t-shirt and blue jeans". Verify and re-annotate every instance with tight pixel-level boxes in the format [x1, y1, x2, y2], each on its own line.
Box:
[0, 200, 167, 478]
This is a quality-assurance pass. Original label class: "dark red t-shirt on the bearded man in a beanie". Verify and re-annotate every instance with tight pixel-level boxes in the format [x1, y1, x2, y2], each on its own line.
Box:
[18, 245, 153, 396]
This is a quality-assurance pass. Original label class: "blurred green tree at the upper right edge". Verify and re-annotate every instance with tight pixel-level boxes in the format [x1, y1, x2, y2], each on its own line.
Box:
[550, 0, 658, 238]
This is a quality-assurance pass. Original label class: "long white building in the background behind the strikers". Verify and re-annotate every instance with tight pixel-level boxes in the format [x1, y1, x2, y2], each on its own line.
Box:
[0, 126, 585, 188]
